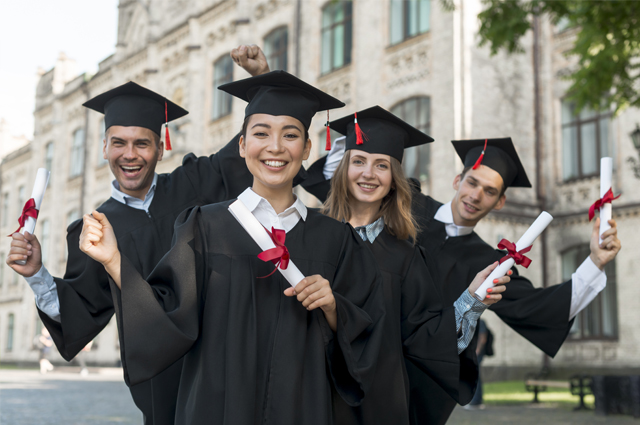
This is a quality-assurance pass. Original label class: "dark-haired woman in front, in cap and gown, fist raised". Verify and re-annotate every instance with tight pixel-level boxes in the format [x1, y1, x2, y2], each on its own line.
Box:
[75, 71, 385, 425]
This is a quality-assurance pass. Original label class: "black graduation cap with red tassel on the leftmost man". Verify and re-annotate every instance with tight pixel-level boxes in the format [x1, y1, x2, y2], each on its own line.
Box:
[82, 81, 189, 150]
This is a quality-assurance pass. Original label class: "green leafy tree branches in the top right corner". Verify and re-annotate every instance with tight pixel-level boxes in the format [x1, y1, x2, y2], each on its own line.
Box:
[478, 0, 640, 114]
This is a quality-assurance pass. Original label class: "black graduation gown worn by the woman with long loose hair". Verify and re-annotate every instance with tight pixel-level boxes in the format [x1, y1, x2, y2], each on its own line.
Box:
[334, 227, 477, 425]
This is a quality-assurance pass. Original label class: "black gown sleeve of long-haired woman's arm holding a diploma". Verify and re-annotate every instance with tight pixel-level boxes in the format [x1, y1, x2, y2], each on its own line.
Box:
[401, 248, 478, 404]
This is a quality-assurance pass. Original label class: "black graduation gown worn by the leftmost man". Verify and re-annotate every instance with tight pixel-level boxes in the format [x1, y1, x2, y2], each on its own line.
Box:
[39, 137, 253, 425]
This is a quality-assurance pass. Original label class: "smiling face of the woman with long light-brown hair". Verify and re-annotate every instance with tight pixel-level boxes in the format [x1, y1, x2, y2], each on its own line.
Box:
[347, 149, 393, 204]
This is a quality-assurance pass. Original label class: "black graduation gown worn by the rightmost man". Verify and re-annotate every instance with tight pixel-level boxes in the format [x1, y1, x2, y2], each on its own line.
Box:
[407, 192, 573, 424]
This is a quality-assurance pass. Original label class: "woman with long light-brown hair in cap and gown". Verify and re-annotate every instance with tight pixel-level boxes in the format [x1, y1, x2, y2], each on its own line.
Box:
[322, 106, 509, 425]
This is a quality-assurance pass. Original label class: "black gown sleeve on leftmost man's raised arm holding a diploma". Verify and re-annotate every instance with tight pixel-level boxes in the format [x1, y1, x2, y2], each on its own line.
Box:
[38, 220, 113, 361]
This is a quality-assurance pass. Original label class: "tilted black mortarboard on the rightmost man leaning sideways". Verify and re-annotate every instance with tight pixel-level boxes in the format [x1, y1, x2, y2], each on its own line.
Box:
[451, 137, 531, 187]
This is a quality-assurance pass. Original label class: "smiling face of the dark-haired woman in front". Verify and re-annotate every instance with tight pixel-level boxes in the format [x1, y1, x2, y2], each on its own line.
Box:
[240, 114, 311, 191]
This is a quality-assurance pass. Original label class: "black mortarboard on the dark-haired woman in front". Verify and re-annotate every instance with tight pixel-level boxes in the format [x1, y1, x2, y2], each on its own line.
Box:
[218, 71, 344, 130]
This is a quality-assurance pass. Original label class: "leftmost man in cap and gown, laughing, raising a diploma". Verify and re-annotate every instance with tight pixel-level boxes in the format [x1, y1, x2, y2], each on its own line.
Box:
[7, 82, 252, 425]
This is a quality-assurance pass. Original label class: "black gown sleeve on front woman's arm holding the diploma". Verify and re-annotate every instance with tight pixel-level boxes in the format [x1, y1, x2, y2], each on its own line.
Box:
[323, 225, 385, 406]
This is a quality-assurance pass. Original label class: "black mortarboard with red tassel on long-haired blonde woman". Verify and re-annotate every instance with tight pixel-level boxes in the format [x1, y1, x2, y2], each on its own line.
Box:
[331, 106, 433, 162]
